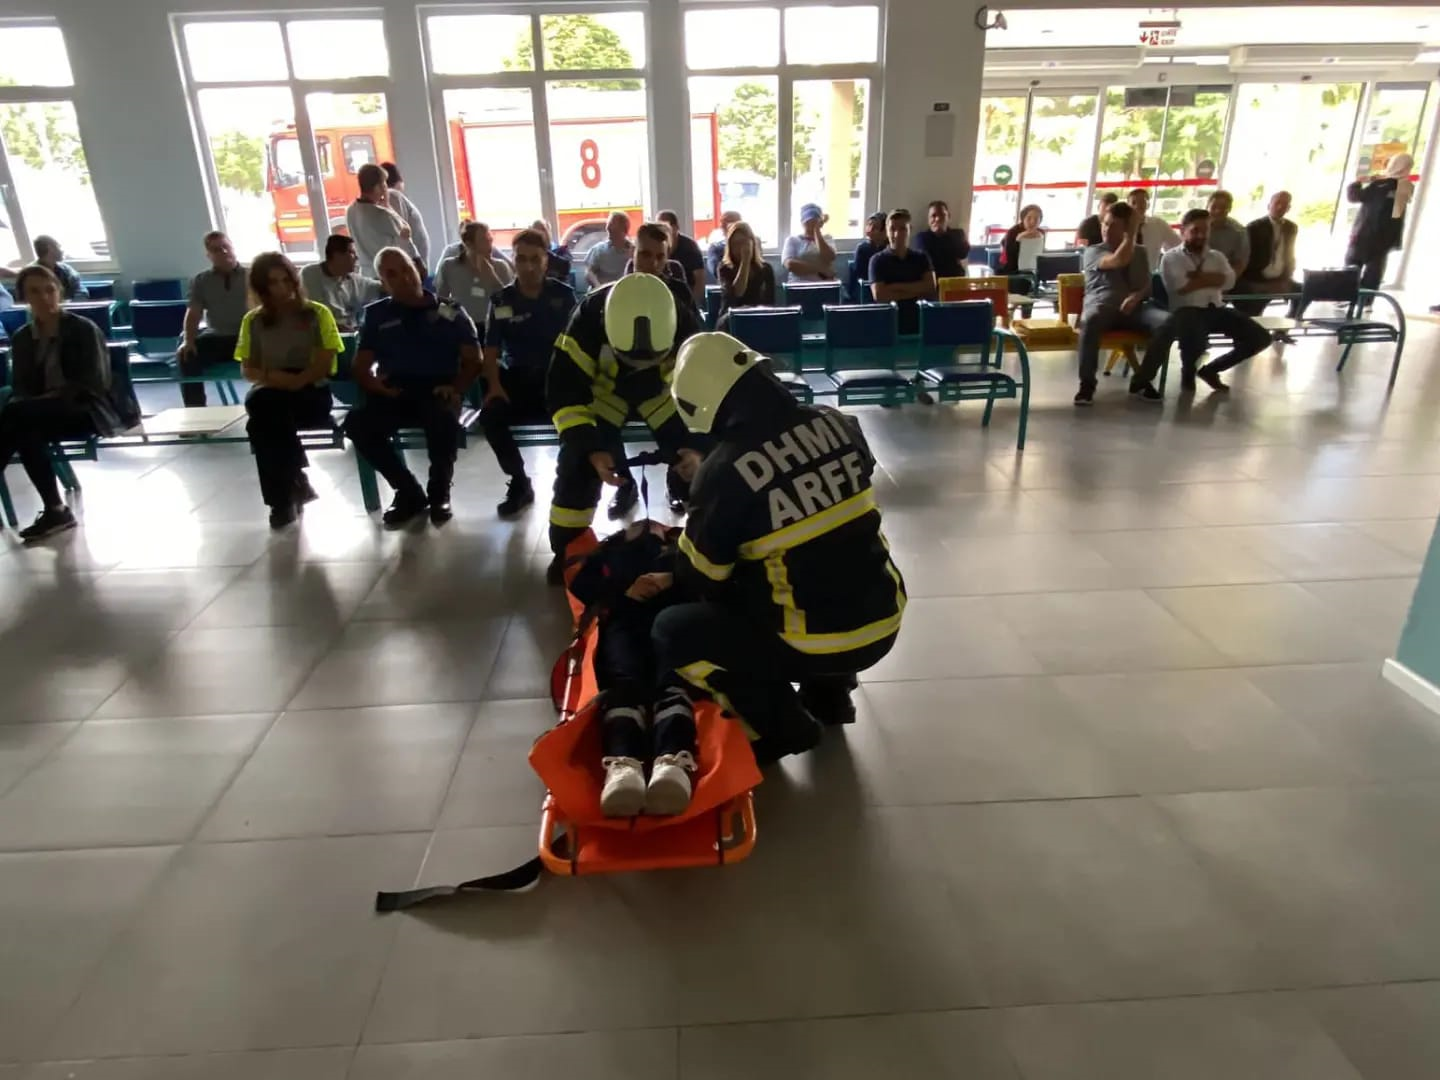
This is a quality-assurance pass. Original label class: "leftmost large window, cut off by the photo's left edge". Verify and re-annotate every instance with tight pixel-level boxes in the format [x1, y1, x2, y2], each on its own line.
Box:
[0, 23, 109, 266]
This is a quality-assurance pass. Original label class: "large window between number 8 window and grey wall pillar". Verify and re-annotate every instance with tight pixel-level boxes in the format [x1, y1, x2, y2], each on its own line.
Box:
[685, 3, 880, 248]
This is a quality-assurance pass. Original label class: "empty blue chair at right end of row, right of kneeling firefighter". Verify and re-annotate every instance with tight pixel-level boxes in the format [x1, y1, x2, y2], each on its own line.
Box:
[920, 300, 1030, 449]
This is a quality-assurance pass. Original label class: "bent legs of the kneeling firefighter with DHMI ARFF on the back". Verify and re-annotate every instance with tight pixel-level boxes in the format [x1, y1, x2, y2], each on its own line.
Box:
[652, 603, 894, 765]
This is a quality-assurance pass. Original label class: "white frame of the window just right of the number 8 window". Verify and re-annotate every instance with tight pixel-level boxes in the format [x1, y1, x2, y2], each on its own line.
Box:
[680, 0, 888, 244]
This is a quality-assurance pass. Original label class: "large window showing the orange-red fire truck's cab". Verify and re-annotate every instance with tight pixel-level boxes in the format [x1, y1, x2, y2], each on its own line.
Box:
[179, 16, 395, 259]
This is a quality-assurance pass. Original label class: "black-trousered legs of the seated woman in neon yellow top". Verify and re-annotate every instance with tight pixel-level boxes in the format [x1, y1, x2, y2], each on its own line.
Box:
[245, 384, 331, 528]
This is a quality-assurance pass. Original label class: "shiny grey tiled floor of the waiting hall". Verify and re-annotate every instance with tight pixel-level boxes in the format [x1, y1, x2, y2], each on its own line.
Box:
[0, 325, 1440, 1080]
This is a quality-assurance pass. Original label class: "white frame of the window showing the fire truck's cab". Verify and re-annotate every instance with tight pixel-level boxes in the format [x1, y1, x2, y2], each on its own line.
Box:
[170, 7, 393, 261]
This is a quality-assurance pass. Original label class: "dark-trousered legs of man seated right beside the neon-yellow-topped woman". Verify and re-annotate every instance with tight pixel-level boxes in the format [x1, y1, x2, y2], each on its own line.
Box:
[344, 383, 459, 528]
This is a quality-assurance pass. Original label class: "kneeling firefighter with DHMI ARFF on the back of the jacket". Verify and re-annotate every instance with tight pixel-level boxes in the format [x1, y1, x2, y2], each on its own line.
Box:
[651, 333, 906, 763]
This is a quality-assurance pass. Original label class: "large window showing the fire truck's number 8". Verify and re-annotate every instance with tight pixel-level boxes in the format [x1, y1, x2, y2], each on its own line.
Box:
[425, 12, 652, 255]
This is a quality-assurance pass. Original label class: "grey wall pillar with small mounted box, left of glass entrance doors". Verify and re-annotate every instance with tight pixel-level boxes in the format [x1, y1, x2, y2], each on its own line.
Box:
[880, 0, 985, 228]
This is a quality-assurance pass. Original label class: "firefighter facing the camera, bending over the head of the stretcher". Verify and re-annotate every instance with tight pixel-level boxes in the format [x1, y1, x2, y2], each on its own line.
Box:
[546, 274, 704, 585]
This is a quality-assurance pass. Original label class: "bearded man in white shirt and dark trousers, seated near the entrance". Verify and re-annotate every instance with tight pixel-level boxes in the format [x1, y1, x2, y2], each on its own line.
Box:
[1130, 210, 1270, 400]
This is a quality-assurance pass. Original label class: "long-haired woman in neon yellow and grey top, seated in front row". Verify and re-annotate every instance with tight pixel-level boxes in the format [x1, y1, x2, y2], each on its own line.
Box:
[235, 252, 344, 528]
